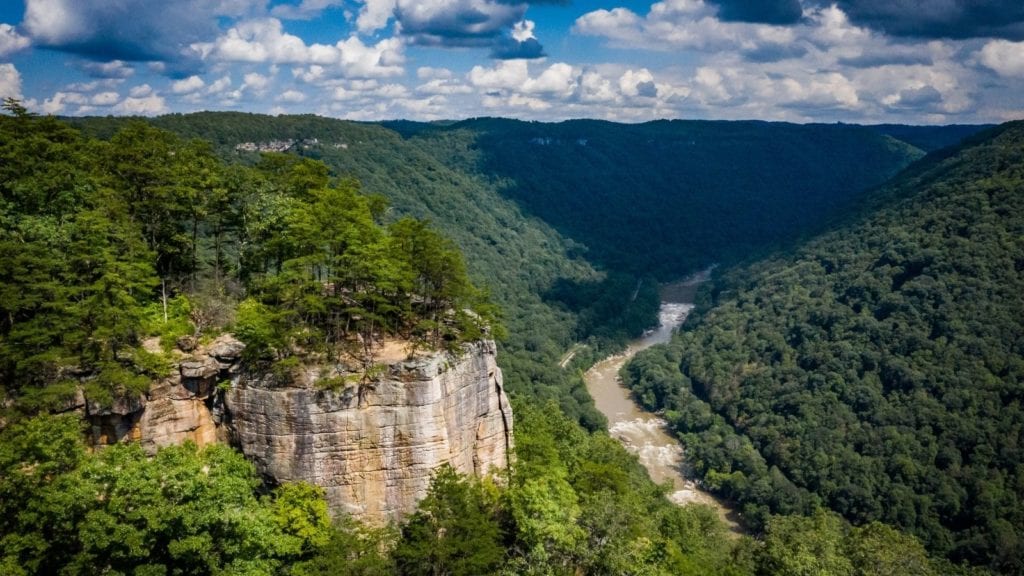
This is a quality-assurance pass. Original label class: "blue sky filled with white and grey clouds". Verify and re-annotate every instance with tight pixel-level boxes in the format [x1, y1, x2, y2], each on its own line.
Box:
[0, 0, 1024, 124]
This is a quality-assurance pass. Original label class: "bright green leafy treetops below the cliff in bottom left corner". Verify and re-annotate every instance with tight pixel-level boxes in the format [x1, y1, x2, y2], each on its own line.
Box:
[0, 415, 332, 574]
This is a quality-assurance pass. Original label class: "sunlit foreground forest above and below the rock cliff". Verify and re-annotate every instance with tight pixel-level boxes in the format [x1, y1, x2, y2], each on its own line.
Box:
[0, 100, 755, 576]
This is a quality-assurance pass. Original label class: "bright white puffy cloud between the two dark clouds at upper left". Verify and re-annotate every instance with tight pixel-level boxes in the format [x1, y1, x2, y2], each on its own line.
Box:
[191, 18, 404, 81]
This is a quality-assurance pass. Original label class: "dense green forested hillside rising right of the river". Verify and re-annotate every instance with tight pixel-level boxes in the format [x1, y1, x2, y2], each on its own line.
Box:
[626, 122, 1024, 574]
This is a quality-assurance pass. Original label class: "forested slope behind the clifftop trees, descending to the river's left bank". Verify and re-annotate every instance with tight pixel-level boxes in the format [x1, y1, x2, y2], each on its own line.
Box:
[74, 113, 630, 429]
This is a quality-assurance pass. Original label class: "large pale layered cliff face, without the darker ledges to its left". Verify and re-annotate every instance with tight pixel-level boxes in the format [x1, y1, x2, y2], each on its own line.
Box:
[225, 341, 512, 522]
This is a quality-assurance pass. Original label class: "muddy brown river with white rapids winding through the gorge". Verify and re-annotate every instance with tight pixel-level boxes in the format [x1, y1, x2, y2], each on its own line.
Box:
[584, 271, 739, 531]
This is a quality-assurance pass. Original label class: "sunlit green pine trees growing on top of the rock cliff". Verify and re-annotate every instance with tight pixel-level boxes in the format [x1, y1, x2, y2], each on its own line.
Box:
[0, 102, 497, 412]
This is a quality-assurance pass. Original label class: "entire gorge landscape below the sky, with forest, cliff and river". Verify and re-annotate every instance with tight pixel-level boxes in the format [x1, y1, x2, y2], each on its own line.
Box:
[0, 109, 1024, 575]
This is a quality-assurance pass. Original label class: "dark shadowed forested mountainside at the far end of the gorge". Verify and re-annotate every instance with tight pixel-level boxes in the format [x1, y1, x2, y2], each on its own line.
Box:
[390, 119, 923, 280]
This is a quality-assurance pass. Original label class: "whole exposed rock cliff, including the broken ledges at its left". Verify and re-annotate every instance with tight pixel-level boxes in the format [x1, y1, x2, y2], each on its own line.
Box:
[75, 336, 513, 523]
